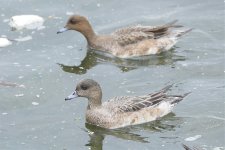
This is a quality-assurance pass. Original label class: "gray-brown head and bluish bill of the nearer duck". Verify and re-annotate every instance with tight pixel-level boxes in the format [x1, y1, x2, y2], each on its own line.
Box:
[65, 79, 102, 101]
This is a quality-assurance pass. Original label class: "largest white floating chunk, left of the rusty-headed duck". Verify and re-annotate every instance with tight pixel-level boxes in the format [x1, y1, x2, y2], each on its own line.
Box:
[9, 15, 44, 30]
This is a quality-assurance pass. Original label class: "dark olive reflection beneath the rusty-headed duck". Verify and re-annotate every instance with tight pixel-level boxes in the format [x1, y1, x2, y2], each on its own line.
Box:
[58, 50, 185, 74]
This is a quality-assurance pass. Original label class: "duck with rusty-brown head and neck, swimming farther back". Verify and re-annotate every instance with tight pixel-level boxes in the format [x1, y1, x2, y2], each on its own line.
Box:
[57, 15, 192, 58]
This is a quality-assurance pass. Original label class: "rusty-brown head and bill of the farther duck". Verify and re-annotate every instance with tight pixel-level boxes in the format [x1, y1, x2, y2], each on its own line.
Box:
[57, 15, 91, 34]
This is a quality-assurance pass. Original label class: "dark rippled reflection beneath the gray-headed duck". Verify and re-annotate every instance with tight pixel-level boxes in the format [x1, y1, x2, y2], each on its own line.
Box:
[85, 113, 180, 150]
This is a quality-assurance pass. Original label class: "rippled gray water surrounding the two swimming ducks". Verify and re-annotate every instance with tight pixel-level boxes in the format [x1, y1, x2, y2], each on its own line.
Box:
[0, 0, 225, 150]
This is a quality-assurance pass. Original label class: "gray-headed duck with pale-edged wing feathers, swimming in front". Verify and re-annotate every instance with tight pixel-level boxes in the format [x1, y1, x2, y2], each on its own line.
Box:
[65, 79, 189, 129]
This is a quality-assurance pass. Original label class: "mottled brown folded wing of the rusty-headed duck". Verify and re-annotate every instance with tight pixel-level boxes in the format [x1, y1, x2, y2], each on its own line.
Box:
[112, 20, 182, 46]
